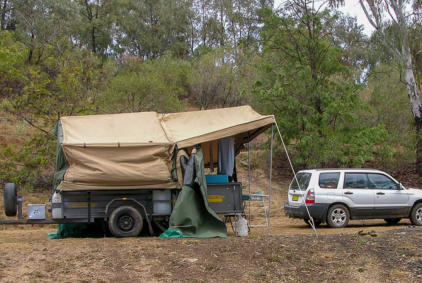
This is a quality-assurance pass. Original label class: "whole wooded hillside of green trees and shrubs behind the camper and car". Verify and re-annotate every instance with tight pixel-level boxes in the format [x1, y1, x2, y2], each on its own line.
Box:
[0, 0, 422, 189]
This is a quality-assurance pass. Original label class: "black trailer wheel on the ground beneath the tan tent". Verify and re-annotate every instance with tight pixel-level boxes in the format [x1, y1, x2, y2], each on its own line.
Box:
[108, 206, 144, 238]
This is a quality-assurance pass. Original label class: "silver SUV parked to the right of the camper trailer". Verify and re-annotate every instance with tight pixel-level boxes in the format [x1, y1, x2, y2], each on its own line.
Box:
[284, 169, 422, 228]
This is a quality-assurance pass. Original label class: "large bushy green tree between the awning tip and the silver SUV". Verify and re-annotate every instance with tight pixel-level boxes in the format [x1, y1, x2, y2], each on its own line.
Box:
[255, 4, 387, 167]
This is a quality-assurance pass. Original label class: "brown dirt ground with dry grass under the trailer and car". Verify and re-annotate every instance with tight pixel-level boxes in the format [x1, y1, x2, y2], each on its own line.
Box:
[0, 170, 422, 282]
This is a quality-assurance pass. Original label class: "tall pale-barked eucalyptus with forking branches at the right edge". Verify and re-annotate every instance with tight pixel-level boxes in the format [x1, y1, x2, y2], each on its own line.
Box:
[359, 0, 422, 176]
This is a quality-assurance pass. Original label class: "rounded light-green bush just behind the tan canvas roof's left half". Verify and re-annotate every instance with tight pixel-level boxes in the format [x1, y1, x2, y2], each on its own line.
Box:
[103, 57, 190, 113]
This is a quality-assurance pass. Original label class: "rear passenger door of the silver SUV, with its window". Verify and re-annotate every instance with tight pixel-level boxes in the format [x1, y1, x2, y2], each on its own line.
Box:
[343, 172, 375, 218]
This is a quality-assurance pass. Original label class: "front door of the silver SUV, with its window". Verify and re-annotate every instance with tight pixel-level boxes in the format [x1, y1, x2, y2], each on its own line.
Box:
[368, 173, 409, 217]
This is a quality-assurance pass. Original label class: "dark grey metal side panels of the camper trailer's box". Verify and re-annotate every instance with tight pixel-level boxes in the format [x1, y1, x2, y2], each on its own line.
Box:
[51, 183, 243, 222]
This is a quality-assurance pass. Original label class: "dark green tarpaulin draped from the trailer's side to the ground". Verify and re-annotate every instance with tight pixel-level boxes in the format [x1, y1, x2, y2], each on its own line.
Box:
[160, 150, 227, 238]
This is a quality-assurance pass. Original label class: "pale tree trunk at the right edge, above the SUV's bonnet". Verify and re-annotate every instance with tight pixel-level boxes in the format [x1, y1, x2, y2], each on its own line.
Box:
[403, 50, 422, 176]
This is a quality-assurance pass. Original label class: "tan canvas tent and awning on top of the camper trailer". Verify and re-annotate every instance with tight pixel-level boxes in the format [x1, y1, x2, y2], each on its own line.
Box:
[55, 106, 274, 190]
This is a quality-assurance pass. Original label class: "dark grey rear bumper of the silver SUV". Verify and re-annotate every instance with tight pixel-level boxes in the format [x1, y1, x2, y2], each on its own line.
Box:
[284, 202, 328, 222]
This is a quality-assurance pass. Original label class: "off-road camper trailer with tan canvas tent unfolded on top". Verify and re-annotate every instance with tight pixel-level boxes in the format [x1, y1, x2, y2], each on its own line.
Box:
[0, 106, 274, 237]
